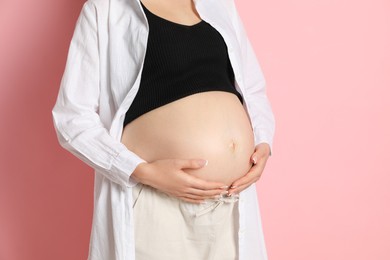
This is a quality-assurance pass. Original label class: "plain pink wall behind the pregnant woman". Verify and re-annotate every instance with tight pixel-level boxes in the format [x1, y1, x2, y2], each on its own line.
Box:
[0, 0, 390, 260]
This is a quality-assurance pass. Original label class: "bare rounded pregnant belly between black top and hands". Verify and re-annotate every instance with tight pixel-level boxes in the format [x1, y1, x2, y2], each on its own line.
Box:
[121, 91, 254, 186]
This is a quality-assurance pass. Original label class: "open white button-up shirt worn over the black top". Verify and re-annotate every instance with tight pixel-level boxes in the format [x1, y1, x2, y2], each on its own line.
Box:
[52, 0, 275, 260]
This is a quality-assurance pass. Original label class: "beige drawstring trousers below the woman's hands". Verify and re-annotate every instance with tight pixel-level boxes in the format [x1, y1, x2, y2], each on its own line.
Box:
[133, 183, 238, 260]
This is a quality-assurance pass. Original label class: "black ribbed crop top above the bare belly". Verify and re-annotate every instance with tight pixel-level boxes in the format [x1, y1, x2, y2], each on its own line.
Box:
[123, 2, 243, 126]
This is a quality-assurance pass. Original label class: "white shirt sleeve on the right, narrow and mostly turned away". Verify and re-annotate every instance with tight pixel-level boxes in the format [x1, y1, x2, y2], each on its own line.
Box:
[231, 0, 275, 155]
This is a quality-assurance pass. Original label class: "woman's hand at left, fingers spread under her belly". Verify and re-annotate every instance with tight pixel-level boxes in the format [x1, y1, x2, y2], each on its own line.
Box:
[131, 159, 228, 203]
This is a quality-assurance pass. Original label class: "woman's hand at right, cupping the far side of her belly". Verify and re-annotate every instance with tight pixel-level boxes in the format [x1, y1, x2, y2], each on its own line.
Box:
[228, 143, 270, 196]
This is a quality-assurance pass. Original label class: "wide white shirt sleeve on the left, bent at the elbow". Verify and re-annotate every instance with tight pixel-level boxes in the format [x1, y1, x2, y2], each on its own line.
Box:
[52, 1, 145, 188]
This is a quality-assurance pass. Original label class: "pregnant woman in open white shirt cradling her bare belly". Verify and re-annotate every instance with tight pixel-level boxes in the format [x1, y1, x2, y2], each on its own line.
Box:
[52, 0, 275, 260]
